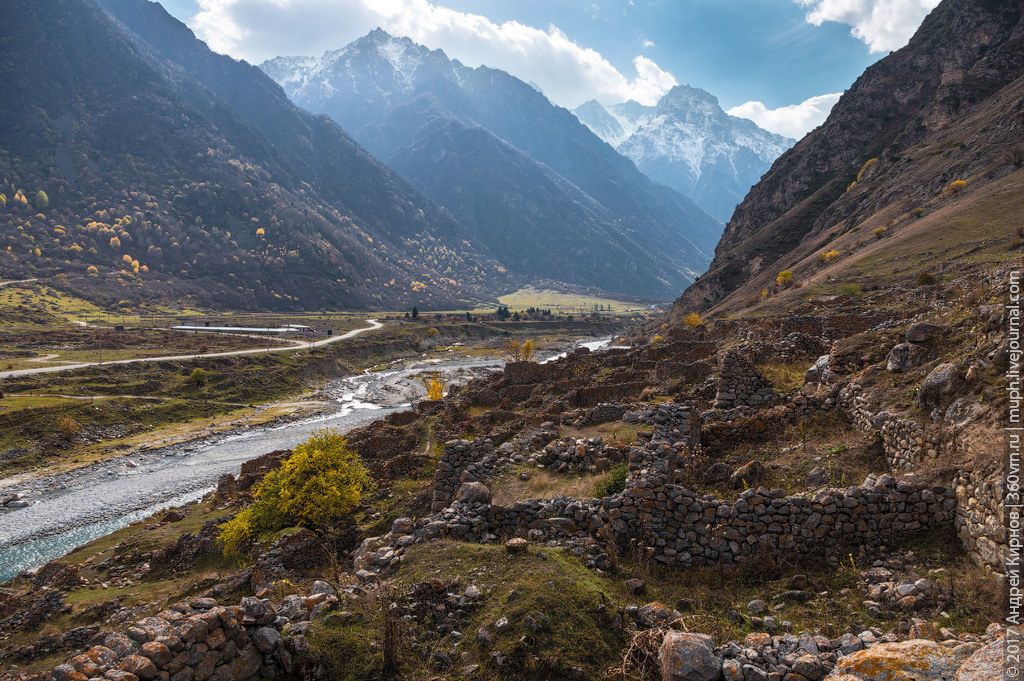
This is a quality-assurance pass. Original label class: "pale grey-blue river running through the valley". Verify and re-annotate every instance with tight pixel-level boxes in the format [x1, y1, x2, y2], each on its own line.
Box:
[0, 339, 610, 583]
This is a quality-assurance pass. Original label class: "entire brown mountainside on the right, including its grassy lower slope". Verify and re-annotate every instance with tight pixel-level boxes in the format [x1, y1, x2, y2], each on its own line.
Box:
[670, 0, 1024, 323]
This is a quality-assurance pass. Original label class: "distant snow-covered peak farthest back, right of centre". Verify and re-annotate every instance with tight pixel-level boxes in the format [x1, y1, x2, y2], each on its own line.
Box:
[573, 85, 795, 221]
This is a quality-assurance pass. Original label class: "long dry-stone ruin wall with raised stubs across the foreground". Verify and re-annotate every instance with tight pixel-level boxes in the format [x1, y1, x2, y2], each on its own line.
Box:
[356, 403, 956, 567]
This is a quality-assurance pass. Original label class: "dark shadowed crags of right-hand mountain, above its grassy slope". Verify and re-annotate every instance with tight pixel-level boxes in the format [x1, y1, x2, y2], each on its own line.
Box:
[677, 0, 1024, 318]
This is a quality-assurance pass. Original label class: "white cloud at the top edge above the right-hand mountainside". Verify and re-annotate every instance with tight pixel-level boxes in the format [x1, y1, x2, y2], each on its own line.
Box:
[795, 0, 940, 52]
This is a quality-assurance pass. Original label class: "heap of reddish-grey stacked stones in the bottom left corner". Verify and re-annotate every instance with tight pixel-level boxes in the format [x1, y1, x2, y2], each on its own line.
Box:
[41, 598, 291, 681]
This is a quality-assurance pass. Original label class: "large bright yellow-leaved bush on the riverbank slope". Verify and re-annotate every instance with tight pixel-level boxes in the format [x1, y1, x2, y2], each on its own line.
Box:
[217, 428, 376, 562]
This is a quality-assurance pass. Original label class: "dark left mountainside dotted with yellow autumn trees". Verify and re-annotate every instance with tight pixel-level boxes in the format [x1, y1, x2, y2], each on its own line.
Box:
[0, 0, 509, 309]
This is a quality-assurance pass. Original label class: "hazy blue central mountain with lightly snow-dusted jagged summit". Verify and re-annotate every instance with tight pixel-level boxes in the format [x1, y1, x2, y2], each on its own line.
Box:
[260, 30, 720, 298]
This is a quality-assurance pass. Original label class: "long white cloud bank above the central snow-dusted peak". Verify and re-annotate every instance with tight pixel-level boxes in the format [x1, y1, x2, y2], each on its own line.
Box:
[191, 0, 677, 108]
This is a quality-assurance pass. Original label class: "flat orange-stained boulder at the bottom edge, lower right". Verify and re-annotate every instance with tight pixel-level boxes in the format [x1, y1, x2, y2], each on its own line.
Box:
[826, 639, 963, 681]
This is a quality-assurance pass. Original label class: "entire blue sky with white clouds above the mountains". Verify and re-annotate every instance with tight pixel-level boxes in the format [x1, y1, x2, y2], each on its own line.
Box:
[160, 0, 939, 138]
